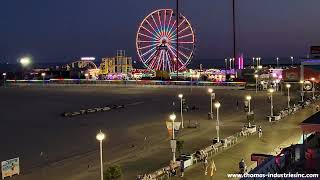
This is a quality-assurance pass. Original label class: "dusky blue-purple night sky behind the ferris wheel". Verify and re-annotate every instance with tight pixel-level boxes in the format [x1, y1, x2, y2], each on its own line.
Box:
[0, 0, 320, 63]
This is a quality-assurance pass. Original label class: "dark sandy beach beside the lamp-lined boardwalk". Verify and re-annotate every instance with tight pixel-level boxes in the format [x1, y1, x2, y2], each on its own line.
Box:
[0, 85, 300, 180]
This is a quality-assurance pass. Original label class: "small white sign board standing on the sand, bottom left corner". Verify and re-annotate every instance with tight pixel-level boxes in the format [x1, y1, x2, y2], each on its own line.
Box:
[1, 158, 20, 179]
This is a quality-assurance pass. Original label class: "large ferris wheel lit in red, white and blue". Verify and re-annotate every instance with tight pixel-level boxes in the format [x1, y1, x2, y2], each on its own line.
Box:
[136, 9, 195, 72]
